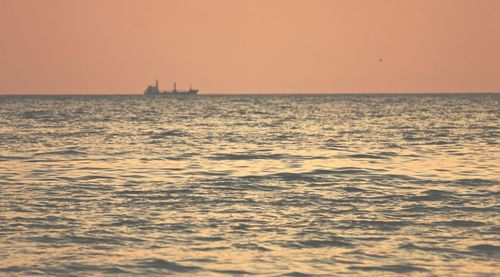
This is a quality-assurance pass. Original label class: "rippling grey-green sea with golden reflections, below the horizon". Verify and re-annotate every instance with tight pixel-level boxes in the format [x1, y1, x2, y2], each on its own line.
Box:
[0, 94, 500, 276]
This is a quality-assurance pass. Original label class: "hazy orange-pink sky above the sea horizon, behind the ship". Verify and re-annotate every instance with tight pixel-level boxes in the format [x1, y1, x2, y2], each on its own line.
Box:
[0, 0, 500, 94]
